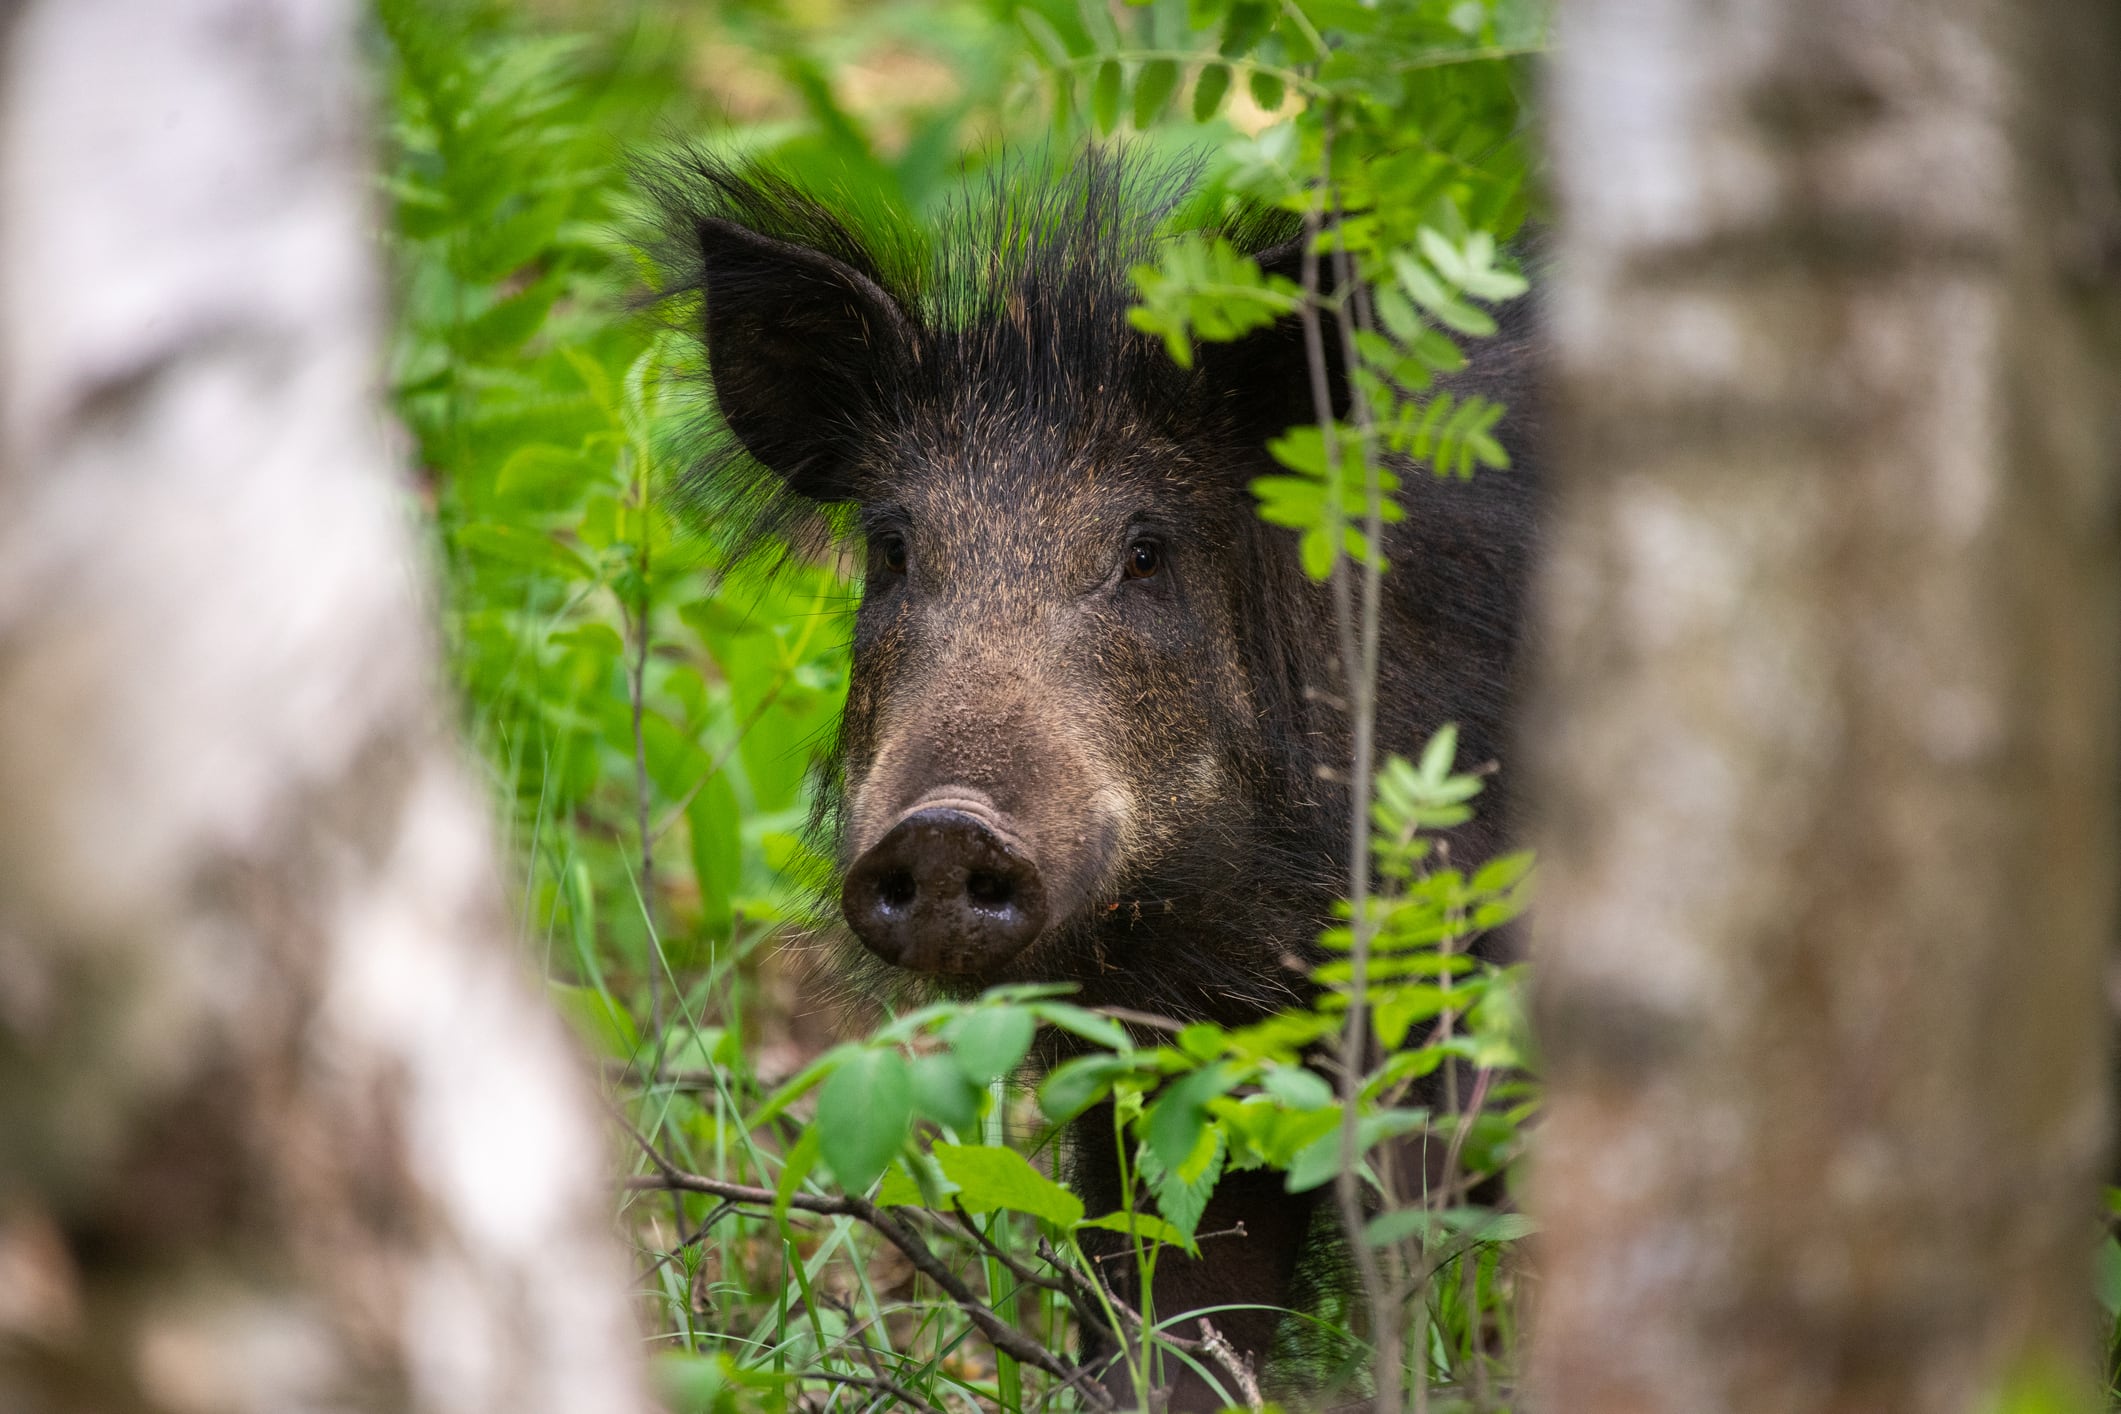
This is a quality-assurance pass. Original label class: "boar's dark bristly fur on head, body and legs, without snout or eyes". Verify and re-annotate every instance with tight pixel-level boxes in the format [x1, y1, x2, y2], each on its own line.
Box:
[645, 153, 1531, 1408]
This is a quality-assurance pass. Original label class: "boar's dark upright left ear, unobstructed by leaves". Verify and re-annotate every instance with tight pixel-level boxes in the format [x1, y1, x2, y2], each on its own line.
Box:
[698, 216, 914, 500]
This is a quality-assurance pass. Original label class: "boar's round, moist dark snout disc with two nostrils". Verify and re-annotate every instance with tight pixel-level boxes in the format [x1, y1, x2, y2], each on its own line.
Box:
[840, 801, 1046, 973]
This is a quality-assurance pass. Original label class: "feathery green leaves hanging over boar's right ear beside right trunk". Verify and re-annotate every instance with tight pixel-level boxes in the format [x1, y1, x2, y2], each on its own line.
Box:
[1024, 0, 1546, 579]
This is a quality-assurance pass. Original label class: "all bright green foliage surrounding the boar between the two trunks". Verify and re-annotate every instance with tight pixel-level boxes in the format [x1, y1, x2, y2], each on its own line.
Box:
[378, 0, 1538, 1412]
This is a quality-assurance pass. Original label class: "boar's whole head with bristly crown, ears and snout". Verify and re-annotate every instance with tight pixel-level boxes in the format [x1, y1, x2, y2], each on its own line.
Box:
[658, 155, 1374, 1018]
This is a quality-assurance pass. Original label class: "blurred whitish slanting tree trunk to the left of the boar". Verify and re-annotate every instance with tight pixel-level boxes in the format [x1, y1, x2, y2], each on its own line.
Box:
[0, 0, 647, 1414]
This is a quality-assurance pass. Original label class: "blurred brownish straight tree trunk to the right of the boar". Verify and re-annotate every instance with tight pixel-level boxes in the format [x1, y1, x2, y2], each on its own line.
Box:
[1529, 0, 2121, 1414]
